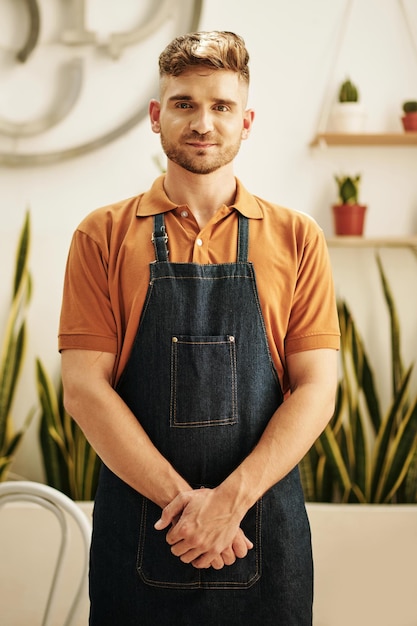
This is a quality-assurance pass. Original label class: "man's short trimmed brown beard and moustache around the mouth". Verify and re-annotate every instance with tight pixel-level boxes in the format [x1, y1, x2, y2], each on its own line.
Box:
[160, 130, 242, 174]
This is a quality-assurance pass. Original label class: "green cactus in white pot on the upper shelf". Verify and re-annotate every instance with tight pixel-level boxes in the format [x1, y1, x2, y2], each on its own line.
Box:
[331, 78, 365, 133]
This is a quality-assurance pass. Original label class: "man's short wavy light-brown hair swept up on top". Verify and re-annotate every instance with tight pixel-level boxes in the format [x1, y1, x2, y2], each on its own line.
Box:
[159, 30, 249, 83]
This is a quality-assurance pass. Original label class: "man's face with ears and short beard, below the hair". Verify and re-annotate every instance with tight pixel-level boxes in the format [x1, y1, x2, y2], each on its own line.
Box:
[150, 67, 253, 174]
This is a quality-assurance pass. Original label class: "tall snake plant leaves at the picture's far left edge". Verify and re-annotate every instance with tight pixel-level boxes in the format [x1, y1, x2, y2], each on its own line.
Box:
[0, 211, 33, 481]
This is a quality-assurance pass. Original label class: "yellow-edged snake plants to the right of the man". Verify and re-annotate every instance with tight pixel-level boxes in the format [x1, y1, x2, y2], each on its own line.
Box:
[300, 256, 417, 503]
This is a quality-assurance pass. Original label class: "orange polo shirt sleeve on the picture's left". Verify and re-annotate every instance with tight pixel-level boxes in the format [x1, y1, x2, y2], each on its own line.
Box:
[58, 230, 117, 354]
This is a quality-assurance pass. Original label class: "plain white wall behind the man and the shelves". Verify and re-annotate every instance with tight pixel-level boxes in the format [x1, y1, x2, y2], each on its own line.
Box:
[0, 0, 417, 480]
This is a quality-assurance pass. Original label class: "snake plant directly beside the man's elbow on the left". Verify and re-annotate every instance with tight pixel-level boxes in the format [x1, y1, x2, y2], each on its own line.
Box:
[36, 359, 101, 500]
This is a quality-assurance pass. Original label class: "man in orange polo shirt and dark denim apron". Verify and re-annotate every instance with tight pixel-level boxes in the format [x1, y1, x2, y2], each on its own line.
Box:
[59, 32, 339, 626]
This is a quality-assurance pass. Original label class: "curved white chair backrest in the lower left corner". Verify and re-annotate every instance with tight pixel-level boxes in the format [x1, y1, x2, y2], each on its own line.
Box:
[0, 481, 91, 626]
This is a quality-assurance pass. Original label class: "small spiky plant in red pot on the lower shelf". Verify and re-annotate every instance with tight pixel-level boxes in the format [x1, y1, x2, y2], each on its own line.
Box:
[332, 174, 366, 236]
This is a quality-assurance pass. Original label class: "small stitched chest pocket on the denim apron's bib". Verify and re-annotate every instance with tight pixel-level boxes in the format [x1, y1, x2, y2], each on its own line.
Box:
[170, 335, 237, 428]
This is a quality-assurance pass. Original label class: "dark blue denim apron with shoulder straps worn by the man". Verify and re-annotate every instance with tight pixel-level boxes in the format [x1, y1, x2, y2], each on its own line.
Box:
[90, 214, 313, 626]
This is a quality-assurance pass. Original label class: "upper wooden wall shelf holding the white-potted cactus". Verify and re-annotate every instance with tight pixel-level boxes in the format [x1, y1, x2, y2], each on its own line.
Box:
[310, 132, 417, 147]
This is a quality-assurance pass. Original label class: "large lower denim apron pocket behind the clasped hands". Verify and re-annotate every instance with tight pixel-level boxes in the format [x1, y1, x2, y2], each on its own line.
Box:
[137, 498, 262, 589]
